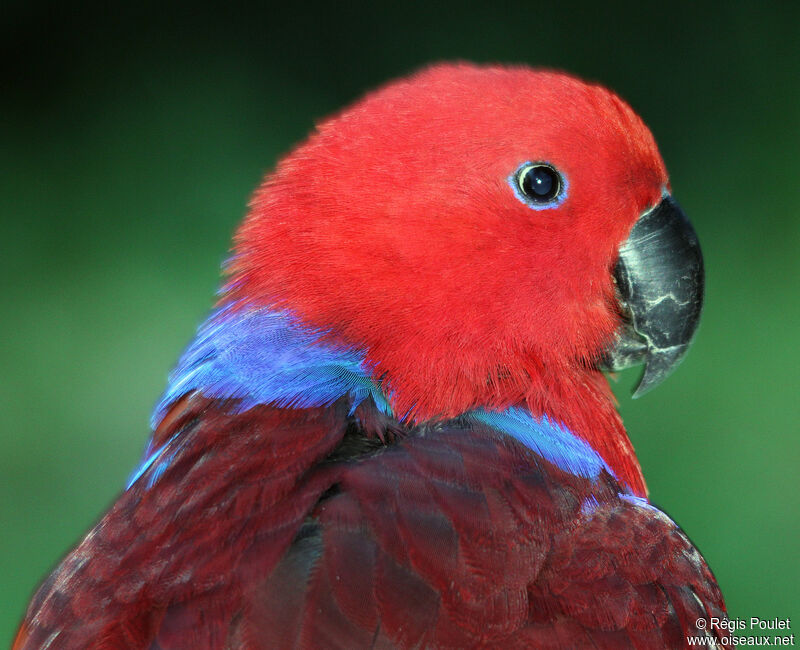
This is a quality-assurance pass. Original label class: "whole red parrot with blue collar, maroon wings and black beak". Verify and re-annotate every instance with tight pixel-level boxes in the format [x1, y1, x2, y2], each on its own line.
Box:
[13, 62, 729, 650]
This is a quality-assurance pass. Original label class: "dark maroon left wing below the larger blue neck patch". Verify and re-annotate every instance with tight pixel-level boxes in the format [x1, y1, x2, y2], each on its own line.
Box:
[15, 396, 348, 648]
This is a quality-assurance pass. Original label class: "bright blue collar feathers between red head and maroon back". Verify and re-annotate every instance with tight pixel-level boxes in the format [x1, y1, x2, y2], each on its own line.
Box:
[128, 305, 613, 487]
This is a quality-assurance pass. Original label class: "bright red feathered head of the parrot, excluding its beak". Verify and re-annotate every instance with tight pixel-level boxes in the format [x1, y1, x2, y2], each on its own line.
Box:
[229, 64, 699, 486]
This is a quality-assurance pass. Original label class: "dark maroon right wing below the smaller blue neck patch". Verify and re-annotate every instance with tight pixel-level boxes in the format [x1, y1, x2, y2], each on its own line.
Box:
[267, 428, 724, 649]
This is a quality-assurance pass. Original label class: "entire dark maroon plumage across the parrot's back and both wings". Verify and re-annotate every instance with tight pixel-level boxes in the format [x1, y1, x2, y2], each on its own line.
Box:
[15, 396, 724, 650]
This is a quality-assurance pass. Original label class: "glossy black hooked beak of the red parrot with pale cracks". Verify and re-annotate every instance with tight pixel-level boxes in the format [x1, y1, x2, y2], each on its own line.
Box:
[603, 196, 705, 397]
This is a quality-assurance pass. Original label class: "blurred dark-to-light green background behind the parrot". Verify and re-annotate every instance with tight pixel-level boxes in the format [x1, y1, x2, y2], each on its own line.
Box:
[0, 2, 800, 644]
